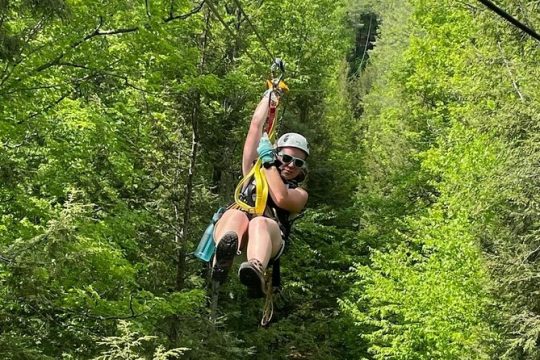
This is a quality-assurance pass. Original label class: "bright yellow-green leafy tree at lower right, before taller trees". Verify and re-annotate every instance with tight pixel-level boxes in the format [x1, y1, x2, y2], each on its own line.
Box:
[344, 124, 504, 359]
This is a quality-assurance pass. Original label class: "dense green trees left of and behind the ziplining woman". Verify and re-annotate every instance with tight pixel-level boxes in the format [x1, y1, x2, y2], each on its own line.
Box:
[0, 0, 362, 359]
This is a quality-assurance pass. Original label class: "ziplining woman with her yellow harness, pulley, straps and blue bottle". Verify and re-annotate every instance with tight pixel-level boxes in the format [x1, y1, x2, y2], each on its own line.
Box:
[195, 59, 309, 326]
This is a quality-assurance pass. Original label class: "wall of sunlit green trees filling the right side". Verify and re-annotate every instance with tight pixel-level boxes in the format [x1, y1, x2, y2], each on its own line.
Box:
[342, 1, 540, 359]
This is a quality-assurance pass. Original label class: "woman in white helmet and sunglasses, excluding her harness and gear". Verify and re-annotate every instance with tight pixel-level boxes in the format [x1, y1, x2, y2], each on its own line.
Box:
[212, 91, 309, 297]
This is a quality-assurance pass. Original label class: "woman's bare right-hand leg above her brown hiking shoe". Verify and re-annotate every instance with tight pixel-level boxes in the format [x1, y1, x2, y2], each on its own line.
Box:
[247, 216, 282, 269]
